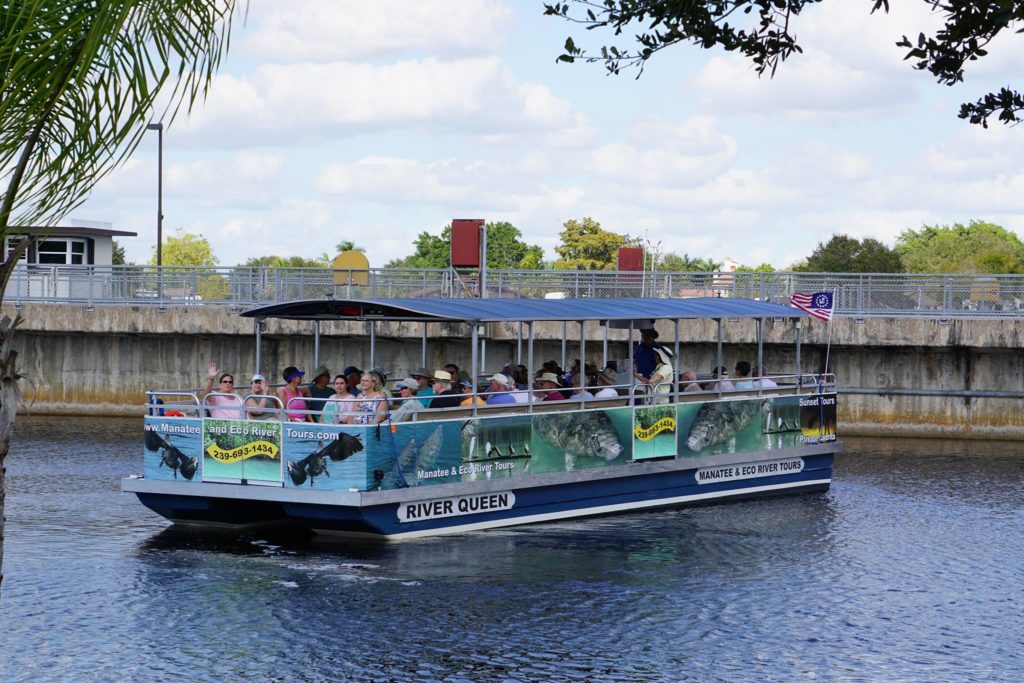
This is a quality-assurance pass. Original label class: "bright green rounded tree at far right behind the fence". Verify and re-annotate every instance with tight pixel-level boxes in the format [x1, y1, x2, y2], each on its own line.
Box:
[896, 220, 1024, 273]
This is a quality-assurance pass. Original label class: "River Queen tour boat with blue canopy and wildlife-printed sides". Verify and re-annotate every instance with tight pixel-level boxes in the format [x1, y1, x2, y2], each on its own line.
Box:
[122, 298, 843, 539]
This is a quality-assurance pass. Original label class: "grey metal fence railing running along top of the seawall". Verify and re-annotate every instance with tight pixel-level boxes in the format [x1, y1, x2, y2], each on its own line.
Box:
[4, 265, 1024, 317]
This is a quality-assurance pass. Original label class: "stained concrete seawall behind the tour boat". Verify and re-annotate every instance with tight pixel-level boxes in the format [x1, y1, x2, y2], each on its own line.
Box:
[9, 304, 1024, 439]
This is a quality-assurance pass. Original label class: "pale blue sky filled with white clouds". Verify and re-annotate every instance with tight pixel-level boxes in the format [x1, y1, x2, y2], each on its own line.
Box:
[72, 0, 1024, 269]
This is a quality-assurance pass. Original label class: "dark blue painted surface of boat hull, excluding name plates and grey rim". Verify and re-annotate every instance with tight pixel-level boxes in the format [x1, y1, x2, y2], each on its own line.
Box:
[130, 453, 834, 539]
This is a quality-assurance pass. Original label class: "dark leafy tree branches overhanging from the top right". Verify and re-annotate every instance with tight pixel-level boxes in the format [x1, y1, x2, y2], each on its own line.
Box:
[544, 0, 1024, 127]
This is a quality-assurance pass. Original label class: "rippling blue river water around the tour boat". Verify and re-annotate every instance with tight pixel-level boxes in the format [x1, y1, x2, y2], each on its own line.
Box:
[0, 418, 1024, 681]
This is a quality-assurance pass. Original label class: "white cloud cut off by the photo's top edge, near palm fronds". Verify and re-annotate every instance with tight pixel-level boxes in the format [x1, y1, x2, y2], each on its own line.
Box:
[240, 0, 513, 61]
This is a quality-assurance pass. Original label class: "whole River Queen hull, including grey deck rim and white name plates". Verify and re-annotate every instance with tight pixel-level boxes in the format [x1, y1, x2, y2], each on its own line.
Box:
[123, 443, 842, 540]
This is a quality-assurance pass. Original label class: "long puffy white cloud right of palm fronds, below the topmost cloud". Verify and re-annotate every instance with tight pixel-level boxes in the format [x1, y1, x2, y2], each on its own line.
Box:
[180, 57, 589, 146]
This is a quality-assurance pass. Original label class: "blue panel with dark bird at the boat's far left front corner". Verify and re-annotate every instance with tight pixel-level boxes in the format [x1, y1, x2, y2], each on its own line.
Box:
[142, 416, 203, 482]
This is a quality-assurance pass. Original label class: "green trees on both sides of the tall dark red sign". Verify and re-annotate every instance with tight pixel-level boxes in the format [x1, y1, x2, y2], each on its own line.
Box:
[385, 221, 544, 270]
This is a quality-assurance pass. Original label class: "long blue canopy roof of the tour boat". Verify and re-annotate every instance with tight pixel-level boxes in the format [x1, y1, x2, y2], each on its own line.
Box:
[242, 297, 807, 323]
